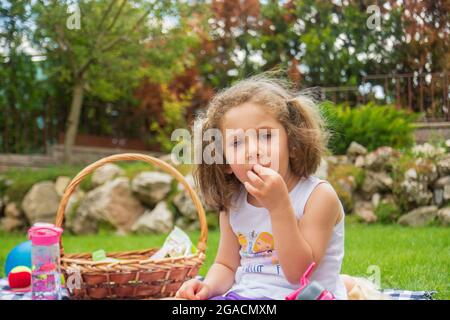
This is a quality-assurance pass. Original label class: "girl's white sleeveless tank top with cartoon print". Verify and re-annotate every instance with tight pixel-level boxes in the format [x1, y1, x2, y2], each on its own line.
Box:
[227, 176, 347, 300]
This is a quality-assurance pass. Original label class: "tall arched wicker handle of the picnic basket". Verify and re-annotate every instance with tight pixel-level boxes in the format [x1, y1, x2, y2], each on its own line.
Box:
[55, 153, 208, 253]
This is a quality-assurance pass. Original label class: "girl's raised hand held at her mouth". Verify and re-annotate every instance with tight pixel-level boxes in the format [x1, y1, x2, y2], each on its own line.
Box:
[244, 164, 290, 213]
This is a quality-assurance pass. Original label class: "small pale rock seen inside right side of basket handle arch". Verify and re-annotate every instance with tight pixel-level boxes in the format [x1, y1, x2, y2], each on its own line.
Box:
[132, 201, 173, 233]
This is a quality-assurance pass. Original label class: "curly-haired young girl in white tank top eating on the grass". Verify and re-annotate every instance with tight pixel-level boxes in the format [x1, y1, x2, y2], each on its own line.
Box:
[176, 76, 347, 300]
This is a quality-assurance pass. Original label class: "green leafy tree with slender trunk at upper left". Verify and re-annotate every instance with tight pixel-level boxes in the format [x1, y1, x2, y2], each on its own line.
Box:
[33, 0, 200, 162]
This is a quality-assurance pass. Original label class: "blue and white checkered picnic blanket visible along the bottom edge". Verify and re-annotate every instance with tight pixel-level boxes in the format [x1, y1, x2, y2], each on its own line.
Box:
[0, 278, 436, 300]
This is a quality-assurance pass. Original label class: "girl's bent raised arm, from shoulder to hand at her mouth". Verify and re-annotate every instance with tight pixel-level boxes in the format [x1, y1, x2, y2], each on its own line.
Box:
[244, 164, 341, 284]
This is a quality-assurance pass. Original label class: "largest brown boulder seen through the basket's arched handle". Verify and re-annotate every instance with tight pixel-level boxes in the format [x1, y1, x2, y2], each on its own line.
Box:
[72, 177, 145, 234]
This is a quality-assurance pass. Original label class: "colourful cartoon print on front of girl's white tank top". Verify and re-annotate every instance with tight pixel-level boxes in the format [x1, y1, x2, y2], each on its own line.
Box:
[236, 230, 281, 275]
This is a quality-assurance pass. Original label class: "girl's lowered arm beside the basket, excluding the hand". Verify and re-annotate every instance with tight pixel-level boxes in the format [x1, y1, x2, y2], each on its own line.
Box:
[203, 211, 240, 297]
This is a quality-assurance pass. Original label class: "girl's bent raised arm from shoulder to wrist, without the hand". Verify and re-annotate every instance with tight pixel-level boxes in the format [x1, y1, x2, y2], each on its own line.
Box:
[271, 183, 341, 284]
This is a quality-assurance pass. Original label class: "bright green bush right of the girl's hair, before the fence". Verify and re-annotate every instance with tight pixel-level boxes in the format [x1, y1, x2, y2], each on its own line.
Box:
[321, 102, 420, 154]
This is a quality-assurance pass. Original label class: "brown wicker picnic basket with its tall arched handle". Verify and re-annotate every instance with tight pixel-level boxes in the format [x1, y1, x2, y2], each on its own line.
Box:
[56, 153, 208, 299]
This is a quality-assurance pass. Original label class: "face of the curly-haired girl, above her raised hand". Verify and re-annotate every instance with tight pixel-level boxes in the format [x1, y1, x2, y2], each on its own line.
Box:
[221, 102, 291, 183]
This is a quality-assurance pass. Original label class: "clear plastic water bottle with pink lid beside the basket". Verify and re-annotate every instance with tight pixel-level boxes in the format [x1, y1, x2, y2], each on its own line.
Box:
[28, 223, 63, 300]
